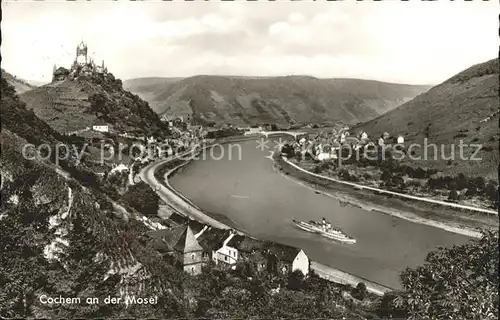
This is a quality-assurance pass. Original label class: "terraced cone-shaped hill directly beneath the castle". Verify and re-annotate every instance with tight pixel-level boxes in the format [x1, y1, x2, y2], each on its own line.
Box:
[20, 74, 168, 135]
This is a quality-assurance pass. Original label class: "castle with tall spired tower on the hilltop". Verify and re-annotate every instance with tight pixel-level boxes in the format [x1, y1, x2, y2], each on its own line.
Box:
[52, 41, 108, 81]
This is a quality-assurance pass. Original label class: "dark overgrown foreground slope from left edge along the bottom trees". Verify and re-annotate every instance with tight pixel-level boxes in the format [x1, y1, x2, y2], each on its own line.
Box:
[0, 74, 376, 319]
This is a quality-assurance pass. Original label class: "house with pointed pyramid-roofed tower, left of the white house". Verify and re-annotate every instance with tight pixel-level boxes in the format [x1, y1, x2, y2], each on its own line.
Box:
[150, 224, 209, 275]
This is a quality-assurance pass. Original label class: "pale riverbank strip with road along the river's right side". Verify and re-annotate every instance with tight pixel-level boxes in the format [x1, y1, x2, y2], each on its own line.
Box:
[275, 157, 498, 238]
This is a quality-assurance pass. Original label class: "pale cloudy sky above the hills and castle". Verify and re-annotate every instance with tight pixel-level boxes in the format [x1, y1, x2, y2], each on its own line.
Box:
[1, 0, 499, 84]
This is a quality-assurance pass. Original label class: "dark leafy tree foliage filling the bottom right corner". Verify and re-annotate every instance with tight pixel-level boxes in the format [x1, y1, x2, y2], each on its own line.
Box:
[383, 231, 499, 320]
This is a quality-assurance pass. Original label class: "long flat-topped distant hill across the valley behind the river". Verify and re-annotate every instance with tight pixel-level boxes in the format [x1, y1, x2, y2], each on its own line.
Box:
[125, 76, 429, 125]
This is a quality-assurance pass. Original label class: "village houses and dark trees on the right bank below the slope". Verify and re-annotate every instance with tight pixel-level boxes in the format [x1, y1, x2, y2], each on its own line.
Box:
[274, 125, 499, 211]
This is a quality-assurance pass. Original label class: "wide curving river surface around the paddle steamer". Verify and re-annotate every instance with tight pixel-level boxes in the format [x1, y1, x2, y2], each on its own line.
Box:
[170, 140, 469, 288]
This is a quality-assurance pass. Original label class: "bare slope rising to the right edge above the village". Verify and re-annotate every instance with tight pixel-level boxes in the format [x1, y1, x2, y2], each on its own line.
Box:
[353, 59, 499, 179]
